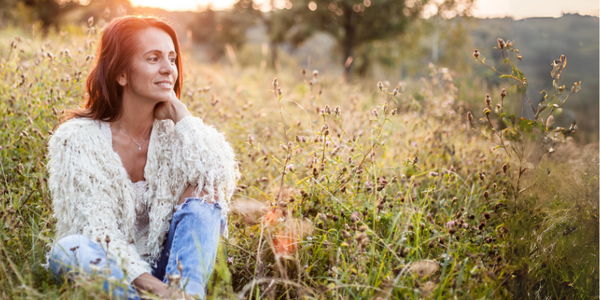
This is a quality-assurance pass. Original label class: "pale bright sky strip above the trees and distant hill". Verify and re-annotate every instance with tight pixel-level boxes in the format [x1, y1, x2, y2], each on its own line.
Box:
[131, 0, 599, 19]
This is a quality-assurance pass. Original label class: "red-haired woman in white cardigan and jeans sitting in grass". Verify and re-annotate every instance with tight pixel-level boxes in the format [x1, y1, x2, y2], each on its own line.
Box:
[48, 16, 239, 299]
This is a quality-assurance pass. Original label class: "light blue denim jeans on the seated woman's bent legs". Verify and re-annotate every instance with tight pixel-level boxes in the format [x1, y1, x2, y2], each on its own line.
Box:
[49, 197, 227, 299]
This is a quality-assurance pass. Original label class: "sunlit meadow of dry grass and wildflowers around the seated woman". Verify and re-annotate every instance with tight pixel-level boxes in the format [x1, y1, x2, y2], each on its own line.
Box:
[0, 22, 599, 299]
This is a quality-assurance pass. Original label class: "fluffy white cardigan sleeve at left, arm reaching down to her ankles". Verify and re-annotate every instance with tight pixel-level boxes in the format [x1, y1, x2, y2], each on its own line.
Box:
[48, 120, 151, 284]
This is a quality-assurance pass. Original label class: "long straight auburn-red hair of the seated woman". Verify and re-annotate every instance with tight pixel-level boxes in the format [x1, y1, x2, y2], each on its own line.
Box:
[61, 16, 183, 123]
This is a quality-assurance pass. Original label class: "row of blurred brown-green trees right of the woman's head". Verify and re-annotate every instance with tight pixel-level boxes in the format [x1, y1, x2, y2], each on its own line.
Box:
[189, 0, 474, 77]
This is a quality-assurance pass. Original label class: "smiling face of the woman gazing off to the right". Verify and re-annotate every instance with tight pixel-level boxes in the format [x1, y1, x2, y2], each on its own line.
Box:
[118, 27, 178, 102]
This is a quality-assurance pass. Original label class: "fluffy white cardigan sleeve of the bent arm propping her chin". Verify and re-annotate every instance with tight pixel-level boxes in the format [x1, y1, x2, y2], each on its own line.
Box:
[173, 116, 240, 215]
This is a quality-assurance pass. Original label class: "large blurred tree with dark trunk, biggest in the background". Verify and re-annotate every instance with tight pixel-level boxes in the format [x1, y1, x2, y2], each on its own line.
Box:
[287, 0, 474, 78]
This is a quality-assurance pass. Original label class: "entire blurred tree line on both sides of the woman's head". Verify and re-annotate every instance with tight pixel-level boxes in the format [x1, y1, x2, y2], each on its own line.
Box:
[0, 0, 475, 78]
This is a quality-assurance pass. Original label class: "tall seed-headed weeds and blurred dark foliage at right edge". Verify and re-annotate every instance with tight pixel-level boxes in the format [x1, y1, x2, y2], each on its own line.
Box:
[467, 39, 599, 299]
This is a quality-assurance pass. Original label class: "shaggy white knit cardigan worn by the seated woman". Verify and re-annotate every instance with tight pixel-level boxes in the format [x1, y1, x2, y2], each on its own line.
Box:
[48, 116, 239, 284]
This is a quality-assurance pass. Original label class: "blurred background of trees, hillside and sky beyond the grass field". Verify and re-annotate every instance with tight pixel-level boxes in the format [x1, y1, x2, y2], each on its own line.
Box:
[0, 0, 599, 143]
